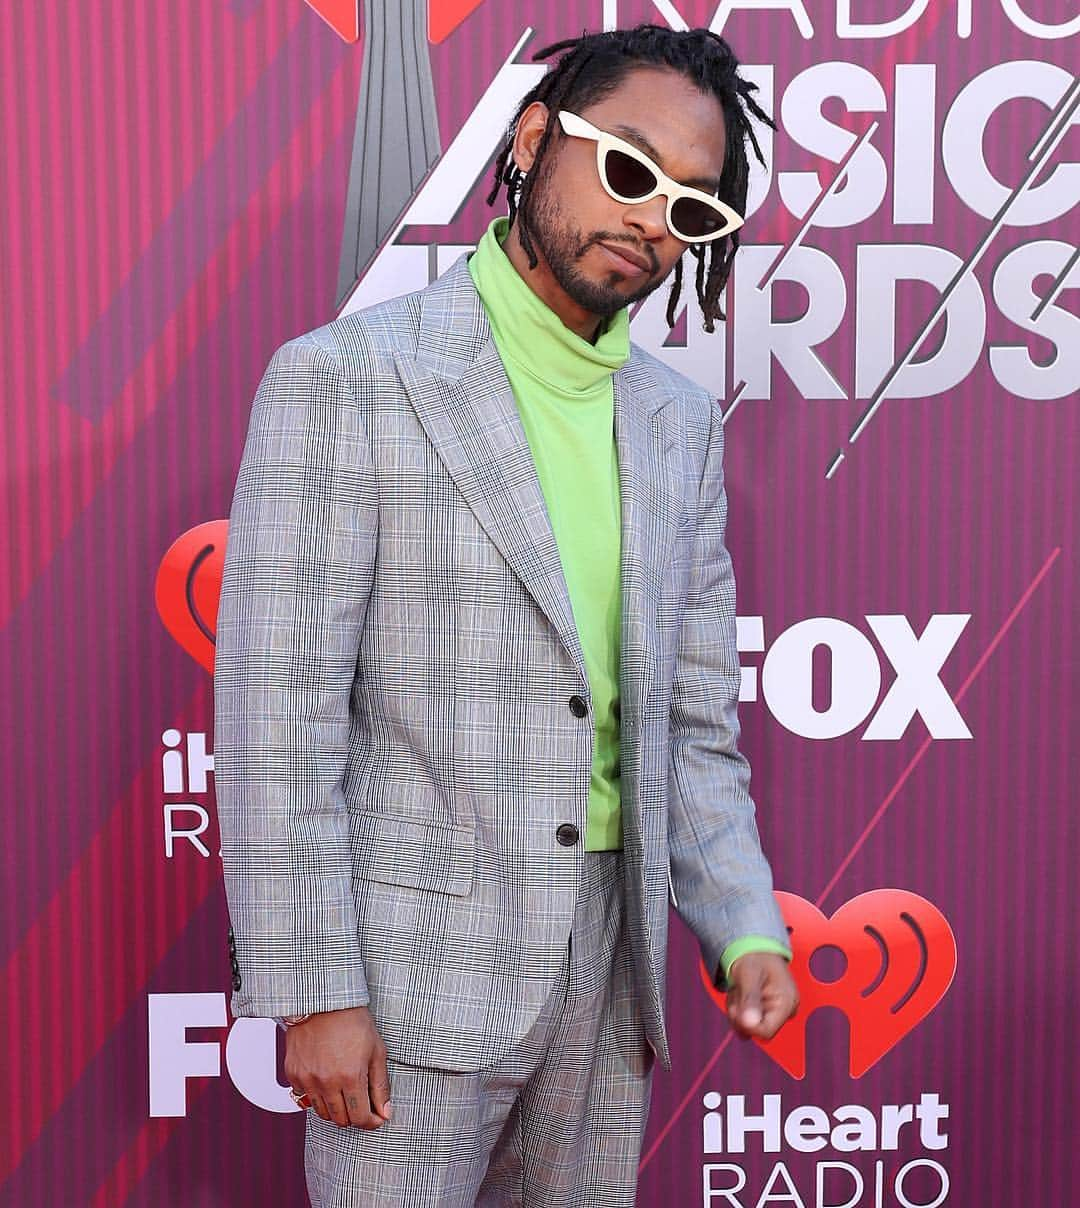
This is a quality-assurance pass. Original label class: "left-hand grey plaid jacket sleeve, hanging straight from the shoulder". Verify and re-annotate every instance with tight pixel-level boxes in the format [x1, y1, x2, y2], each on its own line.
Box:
[214, 333, 378, 1016]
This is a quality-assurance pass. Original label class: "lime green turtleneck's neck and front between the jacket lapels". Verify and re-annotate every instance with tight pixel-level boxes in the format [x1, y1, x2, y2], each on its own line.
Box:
[469, 215, 629, 852]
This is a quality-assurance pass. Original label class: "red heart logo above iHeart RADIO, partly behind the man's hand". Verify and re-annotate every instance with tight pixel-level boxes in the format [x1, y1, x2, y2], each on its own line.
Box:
[701, 889, 957, 1078]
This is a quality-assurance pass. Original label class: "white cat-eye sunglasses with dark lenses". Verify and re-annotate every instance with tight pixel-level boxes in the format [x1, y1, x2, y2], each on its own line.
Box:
[558, 109, 743, 243]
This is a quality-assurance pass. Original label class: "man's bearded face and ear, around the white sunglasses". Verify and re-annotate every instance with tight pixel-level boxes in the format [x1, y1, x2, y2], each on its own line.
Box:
[513, 68, 725, 326]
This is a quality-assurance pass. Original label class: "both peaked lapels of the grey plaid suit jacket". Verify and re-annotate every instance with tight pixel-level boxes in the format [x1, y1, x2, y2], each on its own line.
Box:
[395, 254, 681, 705]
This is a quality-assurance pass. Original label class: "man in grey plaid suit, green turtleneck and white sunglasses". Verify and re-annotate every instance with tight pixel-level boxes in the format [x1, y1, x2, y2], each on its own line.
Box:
[215, 27, 796, 1208]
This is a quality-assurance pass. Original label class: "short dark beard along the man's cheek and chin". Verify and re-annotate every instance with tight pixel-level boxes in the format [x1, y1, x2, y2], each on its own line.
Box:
[518, 163, 664, 321]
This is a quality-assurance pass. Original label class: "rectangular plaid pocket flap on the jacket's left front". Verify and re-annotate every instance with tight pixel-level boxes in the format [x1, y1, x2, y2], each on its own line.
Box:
[352, 809, 475, 896]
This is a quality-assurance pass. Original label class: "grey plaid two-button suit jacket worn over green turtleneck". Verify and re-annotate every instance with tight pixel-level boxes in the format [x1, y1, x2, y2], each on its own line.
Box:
[214, 242, 786, 1070]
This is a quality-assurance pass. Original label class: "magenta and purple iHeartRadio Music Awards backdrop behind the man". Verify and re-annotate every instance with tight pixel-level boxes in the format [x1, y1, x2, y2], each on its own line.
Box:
[0, 0, 1080, 1208]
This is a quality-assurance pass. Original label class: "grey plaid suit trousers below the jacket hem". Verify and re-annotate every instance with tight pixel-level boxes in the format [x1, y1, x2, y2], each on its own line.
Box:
[304, 852, 655, 1208]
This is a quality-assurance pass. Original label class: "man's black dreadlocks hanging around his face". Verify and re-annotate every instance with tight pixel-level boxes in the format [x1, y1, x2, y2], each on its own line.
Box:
[487, 24, 776, 331]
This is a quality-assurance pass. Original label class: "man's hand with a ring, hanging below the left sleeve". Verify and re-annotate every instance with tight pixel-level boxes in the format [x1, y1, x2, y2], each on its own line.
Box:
[285, 1006, 390, 1128]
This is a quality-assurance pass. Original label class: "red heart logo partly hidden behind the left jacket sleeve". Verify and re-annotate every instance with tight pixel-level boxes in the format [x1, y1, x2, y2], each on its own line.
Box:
[153, 521, 228, 675]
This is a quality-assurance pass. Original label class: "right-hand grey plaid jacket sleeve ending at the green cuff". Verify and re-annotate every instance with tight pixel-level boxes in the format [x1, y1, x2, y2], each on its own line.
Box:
[668, 399, 788, 971]
